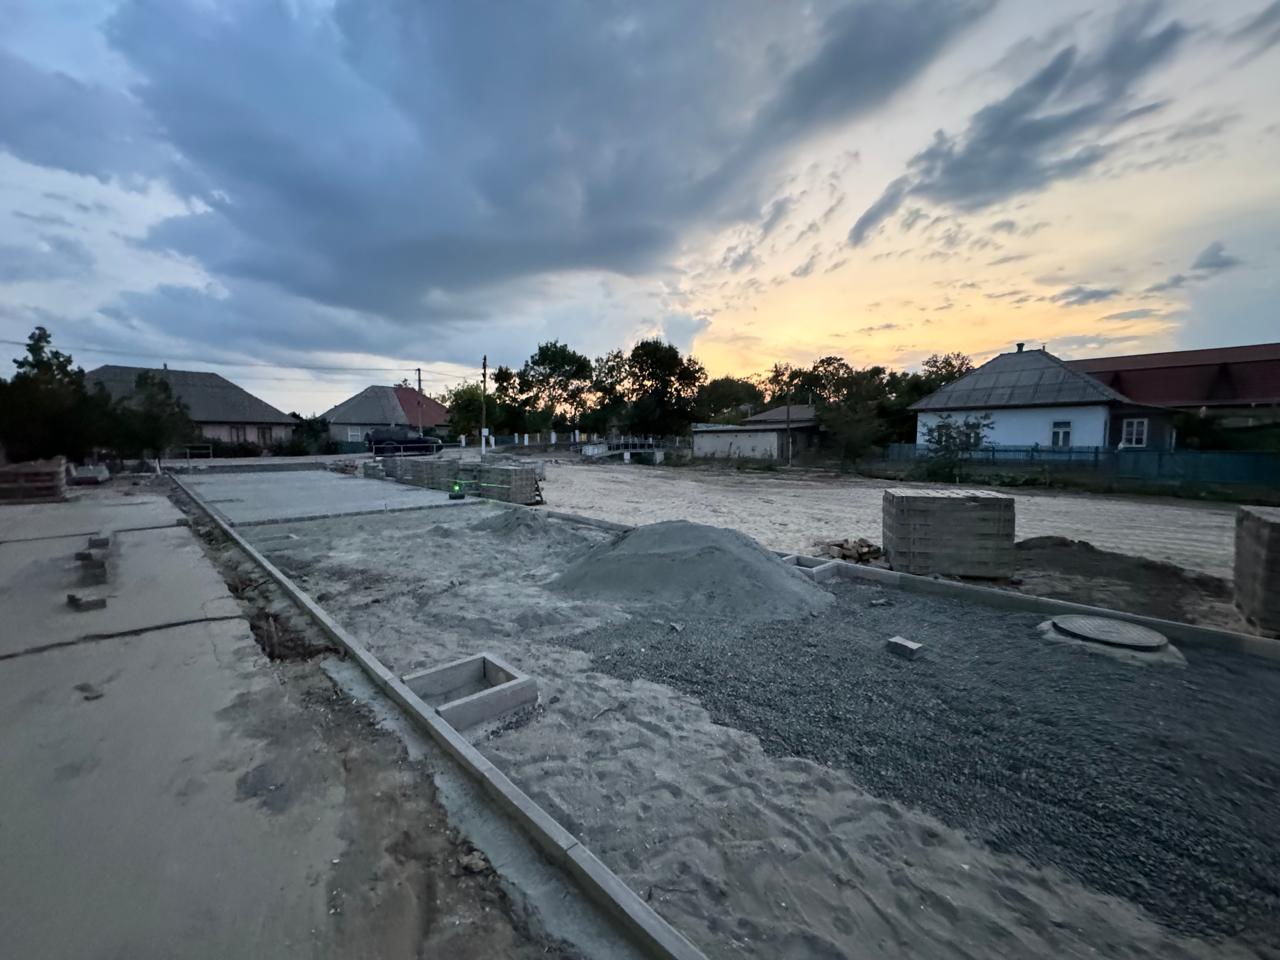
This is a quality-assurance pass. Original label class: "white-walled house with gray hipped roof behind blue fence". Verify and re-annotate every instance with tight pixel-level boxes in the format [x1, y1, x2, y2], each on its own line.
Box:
[911, 343, 1172, 449]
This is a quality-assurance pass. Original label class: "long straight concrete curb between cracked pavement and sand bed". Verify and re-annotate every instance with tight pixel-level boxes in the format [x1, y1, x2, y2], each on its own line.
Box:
[170, 474, 707, 960]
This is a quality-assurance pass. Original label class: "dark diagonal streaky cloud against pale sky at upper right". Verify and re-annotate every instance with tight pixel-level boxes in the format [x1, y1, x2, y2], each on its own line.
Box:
[849, 4, 1189, 246]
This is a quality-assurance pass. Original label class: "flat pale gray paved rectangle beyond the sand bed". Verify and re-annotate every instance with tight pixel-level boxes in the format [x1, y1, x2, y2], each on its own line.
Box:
[183, 470, 460, 526]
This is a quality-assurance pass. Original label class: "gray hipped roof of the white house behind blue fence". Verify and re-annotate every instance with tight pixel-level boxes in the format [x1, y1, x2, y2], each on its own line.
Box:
[911, 349, 1132, 410]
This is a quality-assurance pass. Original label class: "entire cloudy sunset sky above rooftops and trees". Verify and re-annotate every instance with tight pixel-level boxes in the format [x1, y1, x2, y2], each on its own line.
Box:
[0, 0, 1280, 415]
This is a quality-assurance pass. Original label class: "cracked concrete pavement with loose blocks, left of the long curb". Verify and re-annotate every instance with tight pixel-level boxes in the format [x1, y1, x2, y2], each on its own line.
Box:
[0, 492, 561, 960]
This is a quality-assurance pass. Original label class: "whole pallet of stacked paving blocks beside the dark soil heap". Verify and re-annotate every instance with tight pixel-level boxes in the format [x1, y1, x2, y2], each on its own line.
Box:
[883, 490, 1015, 579]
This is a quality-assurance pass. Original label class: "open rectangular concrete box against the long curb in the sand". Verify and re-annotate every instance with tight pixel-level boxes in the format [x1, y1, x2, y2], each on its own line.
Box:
[401, 653, 538, 730]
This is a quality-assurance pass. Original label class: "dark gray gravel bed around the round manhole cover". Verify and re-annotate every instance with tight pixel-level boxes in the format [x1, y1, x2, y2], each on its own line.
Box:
[564, 584, 1280, 945]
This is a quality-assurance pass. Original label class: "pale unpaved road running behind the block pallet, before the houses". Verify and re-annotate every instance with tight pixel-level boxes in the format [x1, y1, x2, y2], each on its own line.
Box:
[543, 462, 1235, 579]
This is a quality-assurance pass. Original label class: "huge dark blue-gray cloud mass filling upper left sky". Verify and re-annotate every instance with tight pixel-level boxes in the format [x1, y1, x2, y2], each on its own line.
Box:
[0, 0, 989, 340]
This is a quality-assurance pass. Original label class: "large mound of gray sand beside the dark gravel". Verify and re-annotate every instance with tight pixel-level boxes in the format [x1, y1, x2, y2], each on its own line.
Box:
[552, 520, 832, 620]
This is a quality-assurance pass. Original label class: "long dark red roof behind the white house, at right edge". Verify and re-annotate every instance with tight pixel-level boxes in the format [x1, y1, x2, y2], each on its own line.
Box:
[1068, 343, 1280, 407]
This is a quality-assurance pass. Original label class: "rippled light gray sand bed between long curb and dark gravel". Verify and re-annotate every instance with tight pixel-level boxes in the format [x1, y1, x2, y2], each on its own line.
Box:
[241, 506, 1256, 960]
